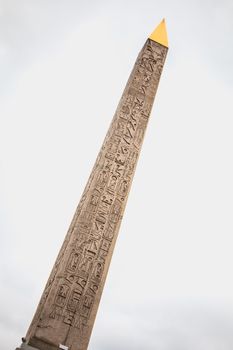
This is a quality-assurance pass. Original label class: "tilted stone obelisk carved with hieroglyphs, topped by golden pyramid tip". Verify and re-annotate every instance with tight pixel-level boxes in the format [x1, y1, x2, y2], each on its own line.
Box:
[17, 20, 168, 350]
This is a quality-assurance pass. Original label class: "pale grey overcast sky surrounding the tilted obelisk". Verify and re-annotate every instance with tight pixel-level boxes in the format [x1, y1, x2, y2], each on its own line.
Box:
[0, 0, 233, 350]
